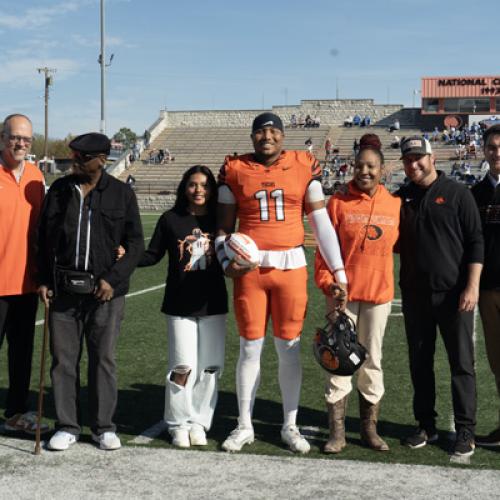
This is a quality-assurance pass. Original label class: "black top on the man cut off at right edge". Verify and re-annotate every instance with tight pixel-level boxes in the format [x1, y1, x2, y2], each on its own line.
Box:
[472, 175, 500, 290]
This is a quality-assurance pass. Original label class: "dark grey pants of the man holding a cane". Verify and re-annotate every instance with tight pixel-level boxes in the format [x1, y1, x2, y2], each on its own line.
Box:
[50, 294, 125, 435]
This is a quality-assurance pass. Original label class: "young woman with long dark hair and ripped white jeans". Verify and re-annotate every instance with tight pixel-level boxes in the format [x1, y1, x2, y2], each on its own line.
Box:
[139, 165, 227, 448]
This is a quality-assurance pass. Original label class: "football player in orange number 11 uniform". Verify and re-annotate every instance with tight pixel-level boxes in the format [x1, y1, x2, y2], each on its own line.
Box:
[215, 113, 347, 453]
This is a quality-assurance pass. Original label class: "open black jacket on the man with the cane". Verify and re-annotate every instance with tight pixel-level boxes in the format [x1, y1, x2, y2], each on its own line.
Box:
[37, 171, 144, 297]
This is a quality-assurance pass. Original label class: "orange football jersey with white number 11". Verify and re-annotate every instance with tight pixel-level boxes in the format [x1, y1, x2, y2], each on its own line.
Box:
[219, 151, 321, 250]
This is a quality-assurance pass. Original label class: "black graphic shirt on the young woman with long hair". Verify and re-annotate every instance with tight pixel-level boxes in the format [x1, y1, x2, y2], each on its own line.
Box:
[139, 209, 227, 316]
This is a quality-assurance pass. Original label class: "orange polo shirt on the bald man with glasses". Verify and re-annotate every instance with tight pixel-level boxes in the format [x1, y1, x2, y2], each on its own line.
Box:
[0, 162, 45, 296]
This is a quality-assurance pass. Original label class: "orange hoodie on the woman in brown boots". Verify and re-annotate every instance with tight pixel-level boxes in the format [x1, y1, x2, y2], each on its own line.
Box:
[314, 181, 401, 304]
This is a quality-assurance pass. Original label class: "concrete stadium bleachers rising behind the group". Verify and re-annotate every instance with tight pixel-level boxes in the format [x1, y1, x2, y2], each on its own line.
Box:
[120, 110, 483, 199]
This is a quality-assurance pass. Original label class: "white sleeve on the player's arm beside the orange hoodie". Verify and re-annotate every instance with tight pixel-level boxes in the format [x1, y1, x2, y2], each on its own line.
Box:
[306, 181, 347, 283]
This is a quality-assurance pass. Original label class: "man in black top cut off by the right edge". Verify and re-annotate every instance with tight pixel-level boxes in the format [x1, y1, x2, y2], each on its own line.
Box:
[472, 125, 500, 447]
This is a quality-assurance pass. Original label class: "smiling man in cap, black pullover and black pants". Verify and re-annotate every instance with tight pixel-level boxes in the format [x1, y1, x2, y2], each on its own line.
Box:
[397, 136, 484, 456]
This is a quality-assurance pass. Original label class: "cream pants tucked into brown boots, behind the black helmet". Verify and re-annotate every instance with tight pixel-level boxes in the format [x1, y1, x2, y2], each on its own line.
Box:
[325, 299, 391, 404]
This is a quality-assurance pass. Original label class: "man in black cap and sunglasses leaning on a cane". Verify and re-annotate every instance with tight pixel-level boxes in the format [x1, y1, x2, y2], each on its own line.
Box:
[38, 133, 144, 450]
